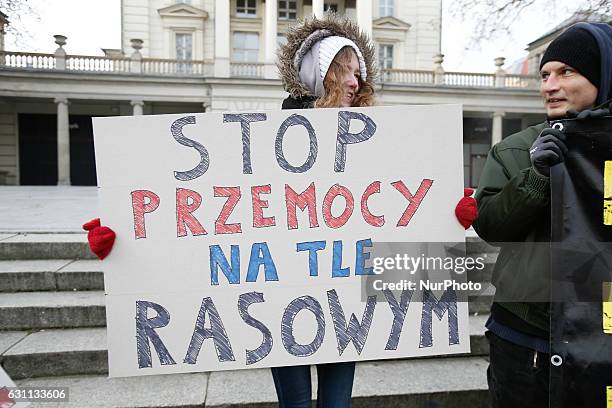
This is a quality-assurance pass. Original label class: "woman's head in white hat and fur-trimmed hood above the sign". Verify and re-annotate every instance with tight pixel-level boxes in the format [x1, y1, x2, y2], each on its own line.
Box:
[278, 15, 376, 109]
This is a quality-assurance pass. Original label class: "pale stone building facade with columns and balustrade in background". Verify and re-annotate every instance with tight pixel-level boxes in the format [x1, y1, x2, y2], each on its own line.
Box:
[0, 0, 544, 185]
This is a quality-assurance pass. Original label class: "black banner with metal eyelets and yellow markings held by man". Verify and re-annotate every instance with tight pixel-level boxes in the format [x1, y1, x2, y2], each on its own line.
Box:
[550, 117, 612, 408]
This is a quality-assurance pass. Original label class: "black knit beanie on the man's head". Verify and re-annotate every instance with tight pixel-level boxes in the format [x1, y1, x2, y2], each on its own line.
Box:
[540, 27, 601, 89]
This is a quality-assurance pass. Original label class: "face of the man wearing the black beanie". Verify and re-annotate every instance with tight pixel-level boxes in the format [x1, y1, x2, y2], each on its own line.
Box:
[540, 61, 597, 119]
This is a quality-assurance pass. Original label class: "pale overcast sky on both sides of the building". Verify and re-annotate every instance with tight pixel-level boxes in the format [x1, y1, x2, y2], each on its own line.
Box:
[6, 0, 575, 72]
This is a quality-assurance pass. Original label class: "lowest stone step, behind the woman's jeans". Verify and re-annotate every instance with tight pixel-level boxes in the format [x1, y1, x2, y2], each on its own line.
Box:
[17, 357, 488, 408]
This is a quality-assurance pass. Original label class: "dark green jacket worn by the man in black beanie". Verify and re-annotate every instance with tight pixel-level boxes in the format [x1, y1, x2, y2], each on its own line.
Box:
[474, 123, 550, 331]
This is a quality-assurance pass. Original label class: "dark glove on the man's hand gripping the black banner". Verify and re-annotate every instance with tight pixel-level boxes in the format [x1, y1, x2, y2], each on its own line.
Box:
[529, 128, 567, 177]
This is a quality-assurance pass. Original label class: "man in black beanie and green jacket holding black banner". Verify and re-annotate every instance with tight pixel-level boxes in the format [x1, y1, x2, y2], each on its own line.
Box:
[474, 23, 612, 408]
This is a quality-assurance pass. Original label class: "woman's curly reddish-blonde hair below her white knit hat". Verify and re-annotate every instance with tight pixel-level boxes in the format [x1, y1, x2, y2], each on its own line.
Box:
[314, 47, 375, 108]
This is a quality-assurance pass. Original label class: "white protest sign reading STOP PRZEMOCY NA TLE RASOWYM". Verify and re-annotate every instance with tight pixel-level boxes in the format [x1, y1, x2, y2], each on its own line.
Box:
[94, 106, 469, 376]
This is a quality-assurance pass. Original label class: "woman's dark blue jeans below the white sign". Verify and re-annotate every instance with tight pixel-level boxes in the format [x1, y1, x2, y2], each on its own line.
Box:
[272, 361, 355, 408]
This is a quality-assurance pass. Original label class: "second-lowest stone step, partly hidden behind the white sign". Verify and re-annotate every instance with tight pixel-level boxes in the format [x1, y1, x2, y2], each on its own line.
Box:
[0, 315, 488, 379]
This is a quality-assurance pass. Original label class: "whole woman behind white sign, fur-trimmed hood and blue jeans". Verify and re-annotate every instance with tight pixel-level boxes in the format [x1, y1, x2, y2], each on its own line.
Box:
[272, 14, 376, 408]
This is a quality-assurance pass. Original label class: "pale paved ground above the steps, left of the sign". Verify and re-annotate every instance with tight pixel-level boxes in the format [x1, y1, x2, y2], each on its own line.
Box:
[0, 186, 98, 233]
